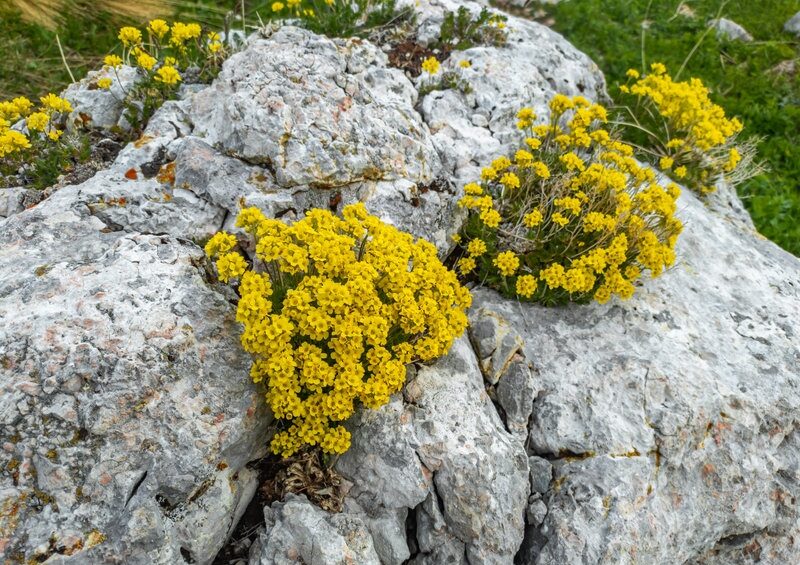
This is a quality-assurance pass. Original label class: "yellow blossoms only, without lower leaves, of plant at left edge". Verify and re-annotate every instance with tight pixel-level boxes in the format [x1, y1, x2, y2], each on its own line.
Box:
[0, 94, 72, 159]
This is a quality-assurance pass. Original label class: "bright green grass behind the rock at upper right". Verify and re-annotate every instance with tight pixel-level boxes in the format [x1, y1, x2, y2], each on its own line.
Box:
[531, 0, 800, 256]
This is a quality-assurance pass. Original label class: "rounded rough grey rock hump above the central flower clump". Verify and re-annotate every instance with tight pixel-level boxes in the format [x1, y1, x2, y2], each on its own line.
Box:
[192, 27, 440, 188]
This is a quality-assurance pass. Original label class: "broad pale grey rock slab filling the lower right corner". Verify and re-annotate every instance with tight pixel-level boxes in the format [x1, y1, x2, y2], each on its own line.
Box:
[471, 186, 800, 565]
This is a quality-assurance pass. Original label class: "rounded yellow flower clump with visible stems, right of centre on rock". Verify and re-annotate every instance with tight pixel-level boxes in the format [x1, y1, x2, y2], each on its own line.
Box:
[457, 95, 682, 304]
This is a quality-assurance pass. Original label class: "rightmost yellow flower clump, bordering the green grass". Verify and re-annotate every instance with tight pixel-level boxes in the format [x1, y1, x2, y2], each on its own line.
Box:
[620, 63, 742, 193]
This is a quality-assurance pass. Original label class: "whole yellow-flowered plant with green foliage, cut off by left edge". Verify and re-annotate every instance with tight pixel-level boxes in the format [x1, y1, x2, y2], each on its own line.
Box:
[0, 94, 83, 188]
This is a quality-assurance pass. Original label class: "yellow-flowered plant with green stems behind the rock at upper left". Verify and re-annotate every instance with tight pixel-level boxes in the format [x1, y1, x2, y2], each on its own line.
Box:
[97, 19, 227, 129]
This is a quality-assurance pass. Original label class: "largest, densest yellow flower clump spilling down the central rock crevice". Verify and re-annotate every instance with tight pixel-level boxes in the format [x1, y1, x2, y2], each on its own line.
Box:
[205, 204, 478, 457]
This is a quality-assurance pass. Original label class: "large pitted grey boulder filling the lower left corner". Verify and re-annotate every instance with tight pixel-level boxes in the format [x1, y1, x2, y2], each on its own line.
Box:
[0, 197, 269, 563]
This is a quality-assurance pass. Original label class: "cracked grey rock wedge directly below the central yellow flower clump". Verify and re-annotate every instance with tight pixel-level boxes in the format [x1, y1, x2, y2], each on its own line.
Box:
[337, 338, 529, 564]
